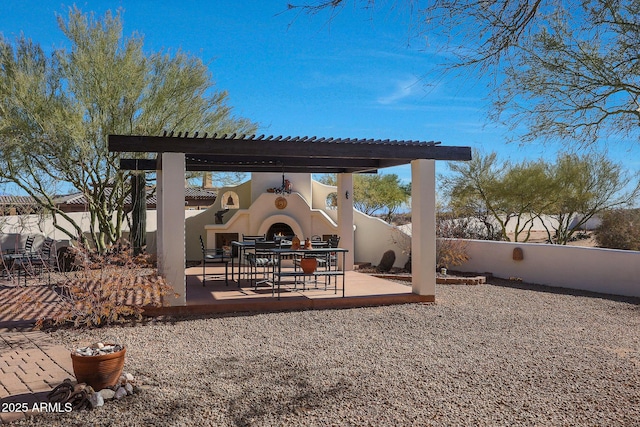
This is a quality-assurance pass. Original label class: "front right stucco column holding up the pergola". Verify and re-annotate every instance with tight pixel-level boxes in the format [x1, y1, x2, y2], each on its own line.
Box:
[411, 159, 436, 297]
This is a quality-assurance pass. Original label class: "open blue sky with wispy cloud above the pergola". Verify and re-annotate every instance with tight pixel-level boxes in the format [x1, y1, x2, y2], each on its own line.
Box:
[0, 0, 640, 189]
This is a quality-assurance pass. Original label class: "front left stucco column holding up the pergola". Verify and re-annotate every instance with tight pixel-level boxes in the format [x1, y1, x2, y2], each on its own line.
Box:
[156, 153, 187, 305]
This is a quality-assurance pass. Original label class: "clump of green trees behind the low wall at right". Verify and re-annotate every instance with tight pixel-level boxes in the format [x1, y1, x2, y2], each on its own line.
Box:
[444, 152, 640, 244]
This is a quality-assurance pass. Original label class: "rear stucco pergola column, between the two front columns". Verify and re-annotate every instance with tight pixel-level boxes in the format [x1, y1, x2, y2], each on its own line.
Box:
[338, 173, 355, 271]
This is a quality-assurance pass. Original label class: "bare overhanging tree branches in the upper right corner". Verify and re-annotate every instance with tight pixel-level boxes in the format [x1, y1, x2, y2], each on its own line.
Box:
[289, 0, 640, 144]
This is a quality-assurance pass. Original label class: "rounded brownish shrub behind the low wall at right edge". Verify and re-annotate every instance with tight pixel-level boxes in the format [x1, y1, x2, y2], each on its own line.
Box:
[595, 209, 640, 251]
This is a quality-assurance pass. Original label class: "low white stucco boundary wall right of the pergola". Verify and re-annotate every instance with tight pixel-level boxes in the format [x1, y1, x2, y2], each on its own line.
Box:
[452, 240, 640, 297]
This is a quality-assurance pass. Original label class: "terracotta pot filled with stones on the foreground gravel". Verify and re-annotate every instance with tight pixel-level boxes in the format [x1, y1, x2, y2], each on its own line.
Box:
[71, 348, 127, 391]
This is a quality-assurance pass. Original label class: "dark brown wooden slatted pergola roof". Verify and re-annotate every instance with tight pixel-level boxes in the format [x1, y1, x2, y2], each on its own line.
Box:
[108, 132, 471, 173]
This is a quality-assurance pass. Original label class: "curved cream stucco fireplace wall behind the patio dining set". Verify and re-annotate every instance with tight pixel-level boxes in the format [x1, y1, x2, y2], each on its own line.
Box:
[198, 173, 411, 267]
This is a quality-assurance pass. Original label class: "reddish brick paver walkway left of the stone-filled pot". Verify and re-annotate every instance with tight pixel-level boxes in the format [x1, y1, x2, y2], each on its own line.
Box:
[0, 284, 75, 425]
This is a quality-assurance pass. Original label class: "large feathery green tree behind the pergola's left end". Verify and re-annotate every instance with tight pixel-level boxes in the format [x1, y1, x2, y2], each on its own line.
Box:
[0, 7, 255, 251]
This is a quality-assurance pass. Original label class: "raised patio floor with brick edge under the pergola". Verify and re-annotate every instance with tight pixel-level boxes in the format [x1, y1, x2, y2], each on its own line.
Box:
[145, 266, 434, 316]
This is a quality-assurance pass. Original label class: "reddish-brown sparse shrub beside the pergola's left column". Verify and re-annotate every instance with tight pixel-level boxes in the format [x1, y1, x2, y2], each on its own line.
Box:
[14, 243, 173, 328]
